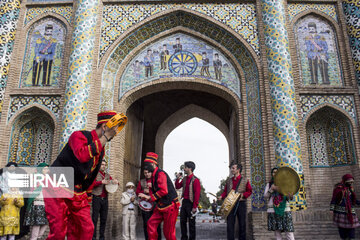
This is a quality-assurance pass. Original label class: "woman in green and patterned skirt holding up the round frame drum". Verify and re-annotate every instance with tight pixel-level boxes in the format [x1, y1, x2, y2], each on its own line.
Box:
[264, 168, 295, 240]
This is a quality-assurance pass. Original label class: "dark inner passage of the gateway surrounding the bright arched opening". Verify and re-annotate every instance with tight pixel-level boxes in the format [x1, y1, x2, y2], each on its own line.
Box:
[123, 86, 245, 188]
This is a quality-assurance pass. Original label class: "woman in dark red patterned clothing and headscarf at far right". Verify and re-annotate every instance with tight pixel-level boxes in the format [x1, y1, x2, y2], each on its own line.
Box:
[330, 174, 360, 239]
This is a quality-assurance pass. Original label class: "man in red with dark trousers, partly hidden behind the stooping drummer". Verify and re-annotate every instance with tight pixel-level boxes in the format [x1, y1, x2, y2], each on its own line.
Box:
[136, 170, 161, 240]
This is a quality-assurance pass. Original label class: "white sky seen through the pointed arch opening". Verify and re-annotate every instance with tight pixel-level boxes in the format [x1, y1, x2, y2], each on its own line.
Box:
[163, 118, 229, 201]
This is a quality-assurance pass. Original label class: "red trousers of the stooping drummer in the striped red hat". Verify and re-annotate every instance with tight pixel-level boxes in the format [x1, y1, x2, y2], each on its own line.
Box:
[147, 203, 179, 240]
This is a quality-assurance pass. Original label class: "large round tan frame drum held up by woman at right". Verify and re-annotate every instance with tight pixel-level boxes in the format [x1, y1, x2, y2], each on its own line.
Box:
[274, 167, 300, 196]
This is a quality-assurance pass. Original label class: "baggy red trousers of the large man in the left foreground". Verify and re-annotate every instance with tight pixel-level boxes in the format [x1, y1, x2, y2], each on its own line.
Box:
[44, 192, 94, 240]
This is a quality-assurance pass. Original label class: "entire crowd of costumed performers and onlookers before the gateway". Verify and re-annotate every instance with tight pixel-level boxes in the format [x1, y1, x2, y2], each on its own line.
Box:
[0, 111, 360, 240]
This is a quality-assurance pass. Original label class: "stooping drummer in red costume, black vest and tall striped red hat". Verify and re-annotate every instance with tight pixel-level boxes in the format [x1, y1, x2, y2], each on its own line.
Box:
[139, 152, 180, 240]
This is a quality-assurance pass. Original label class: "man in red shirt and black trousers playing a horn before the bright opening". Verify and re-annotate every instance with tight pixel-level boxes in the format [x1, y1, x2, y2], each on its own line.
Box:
[175, 161, 201, 240]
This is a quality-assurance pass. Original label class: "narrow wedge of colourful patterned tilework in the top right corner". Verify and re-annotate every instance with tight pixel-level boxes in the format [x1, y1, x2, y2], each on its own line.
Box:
[342, 0, 360, 85]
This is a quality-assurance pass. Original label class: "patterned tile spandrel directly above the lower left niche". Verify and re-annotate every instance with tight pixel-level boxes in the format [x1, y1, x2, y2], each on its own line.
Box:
[7, 96, 61, 121]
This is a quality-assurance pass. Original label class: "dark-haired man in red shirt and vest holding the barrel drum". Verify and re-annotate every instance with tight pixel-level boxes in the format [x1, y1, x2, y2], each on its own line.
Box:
[218, 161, 252, 240]
